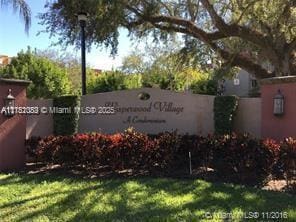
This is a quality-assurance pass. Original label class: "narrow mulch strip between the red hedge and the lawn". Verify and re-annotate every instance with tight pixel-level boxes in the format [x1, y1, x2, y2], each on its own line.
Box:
[18, 162, 296, 194]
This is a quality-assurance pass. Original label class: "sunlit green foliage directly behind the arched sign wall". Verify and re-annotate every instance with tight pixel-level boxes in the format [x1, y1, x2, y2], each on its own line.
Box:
[87, 42, 217, 95]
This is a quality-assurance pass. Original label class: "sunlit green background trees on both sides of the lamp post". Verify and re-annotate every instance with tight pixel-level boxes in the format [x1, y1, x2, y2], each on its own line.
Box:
[0, 46, 220, 99]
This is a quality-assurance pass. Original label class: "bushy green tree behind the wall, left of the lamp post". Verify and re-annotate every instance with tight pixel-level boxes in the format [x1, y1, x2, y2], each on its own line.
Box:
[0, 48, 71, 99]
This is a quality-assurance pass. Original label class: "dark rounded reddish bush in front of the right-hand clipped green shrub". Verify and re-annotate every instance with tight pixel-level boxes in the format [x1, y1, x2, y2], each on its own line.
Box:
[212, 134, 277, 185]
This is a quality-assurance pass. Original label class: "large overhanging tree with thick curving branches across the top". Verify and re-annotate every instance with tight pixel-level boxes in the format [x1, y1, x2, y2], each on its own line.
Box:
[40, 0, 296, 78]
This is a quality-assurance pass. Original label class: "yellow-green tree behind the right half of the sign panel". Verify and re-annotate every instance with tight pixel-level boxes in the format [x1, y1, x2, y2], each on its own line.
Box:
[122, 40, 215, 91]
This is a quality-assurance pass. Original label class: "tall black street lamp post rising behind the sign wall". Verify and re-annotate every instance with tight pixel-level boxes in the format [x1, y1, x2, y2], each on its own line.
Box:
[78, 12, 87, 95]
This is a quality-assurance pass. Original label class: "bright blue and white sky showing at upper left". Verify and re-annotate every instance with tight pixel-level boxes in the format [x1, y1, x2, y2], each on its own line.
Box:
[0, 0, 133, 70]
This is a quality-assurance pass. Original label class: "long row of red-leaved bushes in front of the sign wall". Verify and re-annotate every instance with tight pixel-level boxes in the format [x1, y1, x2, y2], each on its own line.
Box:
[27, 129, 296, 185]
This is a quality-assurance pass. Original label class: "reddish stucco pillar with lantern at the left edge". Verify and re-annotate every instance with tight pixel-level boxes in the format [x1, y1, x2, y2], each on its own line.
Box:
[0, 79, 26, 171]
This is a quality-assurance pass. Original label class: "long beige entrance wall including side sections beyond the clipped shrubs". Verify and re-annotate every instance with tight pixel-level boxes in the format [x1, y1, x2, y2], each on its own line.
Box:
[27, 88, 261, 138]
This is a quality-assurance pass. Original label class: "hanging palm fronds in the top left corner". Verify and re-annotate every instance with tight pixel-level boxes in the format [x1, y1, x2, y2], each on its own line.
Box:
[0, 0, 31, 33]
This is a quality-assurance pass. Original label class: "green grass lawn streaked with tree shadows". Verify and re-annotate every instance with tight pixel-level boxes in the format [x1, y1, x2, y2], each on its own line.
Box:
[0, 174, 296, 222]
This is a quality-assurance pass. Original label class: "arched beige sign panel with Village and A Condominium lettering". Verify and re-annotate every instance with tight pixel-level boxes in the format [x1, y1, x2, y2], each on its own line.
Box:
[79, 88, 214, 135]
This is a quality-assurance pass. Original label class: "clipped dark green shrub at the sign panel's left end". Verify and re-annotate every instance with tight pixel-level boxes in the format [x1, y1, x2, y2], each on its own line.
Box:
[53, 96, 80, 135]
